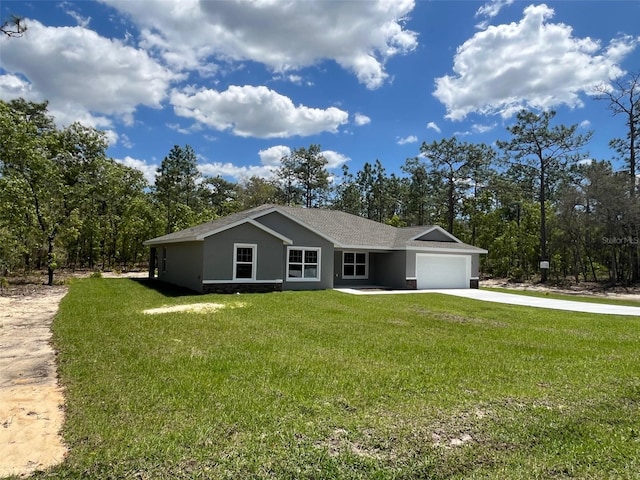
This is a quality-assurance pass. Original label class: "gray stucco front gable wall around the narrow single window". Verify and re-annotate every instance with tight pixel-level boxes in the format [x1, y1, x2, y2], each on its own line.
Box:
[203, 223, 283, 282]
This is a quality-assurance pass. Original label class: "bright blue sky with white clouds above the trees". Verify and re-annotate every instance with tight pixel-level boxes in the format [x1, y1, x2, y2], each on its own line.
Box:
[0, 0, 640, 186]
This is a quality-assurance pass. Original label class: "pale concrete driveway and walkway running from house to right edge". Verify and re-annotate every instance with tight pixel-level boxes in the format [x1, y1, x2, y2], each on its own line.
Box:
[337, 288, 640, 317]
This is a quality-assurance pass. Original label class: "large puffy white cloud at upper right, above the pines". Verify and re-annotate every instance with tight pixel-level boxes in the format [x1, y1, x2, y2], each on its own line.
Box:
[433, 4, 640, 120]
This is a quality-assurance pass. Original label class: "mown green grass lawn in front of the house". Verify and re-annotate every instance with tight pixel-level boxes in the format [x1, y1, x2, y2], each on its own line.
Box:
[27, 279, 640, 479]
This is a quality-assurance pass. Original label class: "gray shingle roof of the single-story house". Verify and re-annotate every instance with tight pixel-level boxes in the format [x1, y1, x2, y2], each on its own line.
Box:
[145, 205, 485, 253]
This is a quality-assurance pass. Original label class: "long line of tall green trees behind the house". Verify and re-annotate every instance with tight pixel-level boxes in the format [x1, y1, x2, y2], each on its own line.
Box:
[0, 75, 640, 283]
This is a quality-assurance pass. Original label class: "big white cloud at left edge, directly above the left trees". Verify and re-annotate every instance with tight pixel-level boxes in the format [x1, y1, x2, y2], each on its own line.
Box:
[0, 20, 177, 126]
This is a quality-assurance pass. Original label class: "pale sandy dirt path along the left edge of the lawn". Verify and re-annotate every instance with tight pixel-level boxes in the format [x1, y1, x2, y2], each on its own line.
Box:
[0, 286, 67, 477]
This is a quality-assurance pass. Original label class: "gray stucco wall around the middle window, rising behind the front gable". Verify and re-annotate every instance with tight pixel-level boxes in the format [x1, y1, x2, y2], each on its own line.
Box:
[255, 212, 334, 290]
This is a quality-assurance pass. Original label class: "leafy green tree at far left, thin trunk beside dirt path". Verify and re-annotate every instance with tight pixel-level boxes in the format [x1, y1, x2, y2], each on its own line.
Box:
[0, 99, 107, 285]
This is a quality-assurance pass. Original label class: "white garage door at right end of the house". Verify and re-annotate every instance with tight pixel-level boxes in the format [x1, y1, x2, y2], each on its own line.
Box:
[416, 253, 471, 289]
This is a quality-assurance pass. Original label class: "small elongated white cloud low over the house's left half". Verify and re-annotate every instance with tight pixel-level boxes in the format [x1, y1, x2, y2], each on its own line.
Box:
[171, 85, 349, 138]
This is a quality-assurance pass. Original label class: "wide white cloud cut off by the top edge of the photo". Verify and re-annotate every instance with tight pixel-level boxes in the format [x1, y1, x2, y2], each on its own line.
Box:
[102, 0, 417, 89]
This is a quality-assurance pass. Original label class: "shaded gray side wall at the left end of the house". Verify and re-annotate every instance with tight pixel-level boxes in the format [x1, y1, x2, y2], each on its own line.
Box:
[157, 242, 202, 292]
